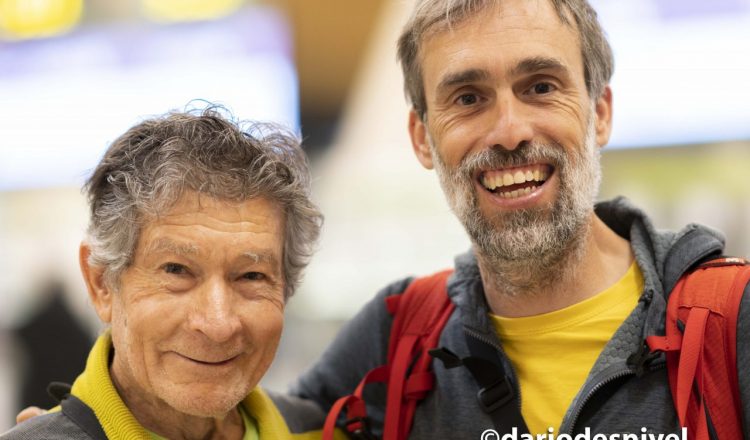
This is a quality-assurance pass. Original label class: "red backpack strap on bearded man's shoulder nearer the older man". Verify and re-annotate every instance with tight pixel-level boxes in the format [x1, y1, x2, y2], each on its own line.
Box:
[323, 270, 455, 440]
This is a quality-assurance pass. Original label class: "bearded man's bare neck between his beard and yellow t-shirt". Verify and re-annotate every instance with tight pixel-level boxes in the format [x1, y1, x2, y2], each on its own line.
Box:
[477, 213, 633, 318]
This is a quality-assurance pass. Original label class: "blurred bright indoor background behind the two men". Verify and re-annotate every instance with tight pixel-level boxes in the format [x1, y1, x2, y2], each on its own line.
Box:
[0, 0, 750, 432]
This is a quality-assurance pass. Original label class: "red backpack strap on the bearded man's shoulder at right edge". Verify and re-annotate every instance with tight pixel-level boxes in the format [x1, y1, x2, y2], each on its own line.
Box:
[646, 258, 750, 440]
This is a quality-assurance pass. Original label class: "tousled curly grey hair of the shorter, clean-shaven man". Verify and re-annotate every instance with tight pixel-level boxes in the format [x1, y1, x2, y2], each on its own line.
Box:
[84, 107, 323, 297]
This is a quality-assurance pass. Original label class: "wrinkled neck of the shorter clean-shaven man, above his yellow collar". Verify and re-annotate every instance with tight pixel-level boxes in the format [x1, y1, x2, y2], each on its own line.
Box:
[110, 360, 245, 440]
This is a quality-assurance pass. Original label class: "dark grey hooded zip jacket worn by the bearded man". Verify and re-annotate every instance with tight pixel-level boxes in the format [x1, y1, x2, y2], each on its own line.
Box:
[292, 198, 750, 439]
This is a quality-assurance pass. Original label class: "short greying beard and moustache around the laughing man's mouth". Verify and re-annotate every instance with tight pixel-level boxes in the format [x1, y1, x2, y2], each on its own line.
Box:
[430, 120, 601, 296]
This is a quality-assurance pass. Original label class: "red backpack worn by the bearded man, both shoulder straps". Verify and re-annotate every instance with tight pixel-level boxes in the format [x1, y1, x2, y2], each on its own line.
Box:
[323, 258, 750, 440]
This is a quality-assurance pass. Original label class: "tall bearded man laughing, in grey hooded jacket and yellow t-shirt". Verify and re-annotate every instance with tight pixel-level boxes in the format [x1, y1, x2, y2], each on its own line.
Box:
[294, 0, 750, 440]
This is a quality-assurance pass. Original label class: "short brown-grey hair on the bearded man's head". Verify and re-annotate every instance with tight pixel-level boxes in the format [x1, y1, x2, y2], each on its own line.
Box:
[398, 0, 614, 120]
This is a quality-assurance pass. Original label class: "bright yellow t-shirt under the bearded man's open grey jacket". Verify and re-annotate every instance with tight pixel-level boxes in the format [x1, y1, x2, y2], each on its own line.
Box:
[490, 262, 643, 435]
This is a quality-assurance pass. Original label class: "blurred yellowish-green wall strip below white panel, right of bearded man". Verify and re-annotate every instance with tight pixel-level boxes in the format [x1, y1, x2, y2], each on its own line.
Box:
[601, 141, 750, 257]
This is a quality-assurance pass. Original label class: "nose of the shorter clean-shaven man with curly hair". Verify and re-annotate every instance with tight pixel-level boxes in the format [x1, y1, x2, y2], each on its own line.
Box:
[190, 280, 241, 342]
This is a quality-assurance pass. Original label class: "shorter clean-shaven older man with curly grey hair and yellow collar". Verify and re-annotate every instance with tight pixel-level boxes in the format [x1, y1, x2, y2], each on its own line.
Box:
[2, 109, 340, 439]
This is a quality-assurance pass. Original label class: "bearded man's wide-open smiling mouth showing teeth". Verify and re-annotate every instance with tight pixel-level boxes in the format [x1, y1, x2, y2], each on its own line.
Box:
[479, 164, 554, 199]
